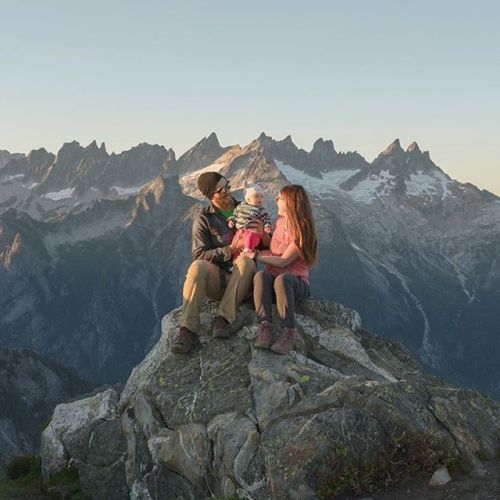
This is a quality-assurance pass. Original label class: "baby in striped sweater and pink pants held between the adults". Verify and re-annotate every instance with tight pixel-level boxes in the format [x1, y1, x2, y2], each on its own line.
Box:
[227, 181, 271, 252]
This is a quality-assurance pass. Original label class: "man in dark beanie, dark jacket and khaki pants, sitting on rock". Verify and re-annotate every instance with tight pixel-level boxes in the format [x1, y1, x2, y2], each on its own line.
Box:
[171, 172, 269, 354]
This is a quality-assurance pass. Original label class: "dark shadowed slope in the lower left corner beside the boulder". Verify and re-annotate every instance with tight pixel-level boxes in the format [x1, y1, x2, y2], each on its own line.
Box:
[0, 348, 90, 477]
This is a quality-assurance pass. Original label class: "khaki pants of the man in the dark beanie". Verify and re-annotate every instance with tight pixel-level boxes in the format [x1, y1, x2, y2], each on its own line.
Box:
[180, 257, 256, 334]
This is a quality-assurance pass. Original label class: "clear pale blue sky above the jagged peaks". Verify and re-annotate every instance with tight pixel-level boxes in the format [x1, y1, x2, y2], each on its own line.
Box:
[0, 0, 500, 195]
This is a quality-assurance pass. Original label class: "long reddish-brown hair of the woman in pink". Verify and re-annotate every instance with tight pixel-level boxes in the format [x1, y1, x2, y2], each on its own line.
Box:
[280, 184, 318, 267]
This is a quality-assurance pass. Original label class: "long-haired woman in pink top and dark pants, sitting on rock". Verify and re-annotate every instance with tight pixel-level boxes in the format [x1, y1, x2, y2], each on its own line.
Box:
[245, 185, 318, 354]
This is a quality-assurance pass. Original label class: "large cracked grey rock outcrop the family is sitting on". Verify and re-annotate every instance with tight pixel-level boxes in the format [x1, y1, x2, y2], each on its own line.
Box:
[42, 301, 500, 499]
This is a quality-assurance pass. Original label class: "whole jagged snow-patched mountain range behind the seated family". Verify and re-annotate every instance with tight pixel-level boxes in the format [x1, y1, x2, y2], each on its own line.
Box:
[0, 133, 500, 398]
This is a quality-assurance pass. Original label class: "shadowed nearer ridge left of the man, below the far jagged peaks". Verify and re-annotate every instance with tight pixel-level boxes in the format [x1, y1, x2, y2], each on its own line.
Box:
[0, 176, 192, 383]
